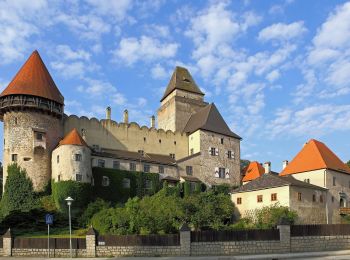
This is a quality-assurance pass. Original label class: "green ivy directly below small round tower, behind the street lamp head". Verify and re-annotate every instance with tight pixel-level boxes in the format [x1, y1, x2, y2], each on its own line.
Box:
[51, 180, 91, 216]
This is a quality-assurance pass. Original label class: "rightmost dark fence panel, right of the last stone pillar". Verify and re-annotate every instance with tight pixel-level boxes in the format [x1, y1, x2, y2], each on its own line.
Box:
[290, 224, 350, 237]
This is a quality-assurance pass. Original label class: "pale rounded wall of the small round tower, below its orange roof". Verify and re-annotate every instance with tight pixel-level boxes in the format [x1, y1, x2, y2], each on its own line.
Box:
[51, 145, 92, 183]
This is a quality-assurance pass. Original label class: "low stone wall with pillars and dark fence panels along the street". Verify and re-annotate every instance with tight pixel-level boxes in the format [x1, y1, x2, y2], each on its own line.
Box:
[0, 224, 350, 257]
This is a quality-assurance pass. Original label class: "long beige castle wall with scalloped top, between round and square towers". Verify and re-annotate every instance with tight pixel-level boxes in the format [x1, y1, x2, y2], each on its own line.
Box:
[64, 115, 188, 159]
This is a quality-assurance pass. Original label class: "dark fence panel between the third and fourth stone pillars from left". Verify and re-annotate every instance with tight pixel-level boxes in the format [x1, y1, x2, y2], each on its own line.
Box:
[191, 229, 280, 242]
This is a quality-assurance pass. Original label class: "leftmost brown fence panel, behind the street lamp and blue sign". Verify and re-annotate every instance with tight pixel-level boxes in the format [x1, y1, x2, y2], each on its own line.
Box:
[13, 237, 86, 249]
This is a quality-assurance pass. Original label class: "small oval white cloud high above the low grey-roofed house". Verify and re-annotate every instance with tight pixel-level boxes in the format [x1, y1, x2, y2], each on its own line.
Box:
[258, 21, 307, 41]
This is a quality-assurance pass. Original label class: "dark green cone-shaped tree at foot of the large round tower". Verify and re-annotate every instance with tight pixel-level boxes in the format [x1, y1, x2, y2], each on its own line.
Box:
[0, 164, 38, 217]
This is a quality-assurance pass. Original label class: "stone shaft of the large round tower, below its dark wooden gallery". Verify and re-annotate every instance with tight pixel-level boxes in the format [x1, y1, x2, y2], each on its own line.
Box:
[3, 111, 63, 191]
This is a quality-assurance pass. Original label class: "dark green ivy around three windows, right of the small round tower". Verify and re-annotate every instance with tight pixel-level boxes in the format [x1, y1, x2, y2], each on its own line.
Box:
[92, 167, 160, 203]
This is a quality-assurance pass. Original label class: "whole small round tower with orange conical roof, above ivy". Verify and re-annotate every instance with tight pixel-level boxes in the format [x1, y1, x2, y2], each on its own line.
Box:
[52, 128, 92, 183]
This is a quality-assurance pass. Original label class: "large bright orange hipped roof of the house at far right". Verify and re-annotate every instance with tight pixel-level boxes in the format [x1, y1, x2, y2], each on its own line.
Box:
[280, 139, 350, 176]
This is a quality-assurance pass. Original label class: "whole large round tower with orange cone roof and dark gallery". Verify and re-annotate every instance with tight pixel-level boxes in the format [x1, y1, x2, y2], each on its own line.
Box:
[0, 51, 64, 191]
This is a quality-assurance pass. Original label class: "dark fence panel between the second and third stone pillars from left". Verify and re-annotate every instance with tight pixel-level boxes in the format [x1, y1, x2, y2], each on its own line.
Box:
[97, 234, 180, 246]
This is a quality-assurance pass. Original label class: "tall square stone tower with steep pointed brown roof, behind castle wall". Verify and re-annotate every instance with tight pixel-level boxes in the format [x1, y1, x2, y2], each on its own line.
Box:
[158, 67, 207, 131]
